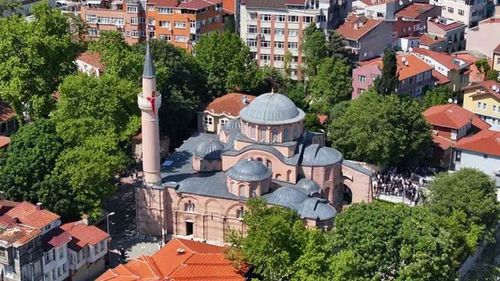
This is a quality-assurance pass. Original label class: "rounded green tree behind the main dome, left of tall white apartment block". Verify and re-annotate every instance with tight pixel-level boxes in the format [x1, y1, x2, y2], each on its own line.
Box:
[194, 32, 258, 97]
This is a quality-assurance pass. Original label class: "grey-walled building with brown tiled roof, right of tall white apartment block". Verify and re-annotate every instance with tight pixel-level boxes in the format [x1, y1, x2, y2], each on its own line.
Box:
[336, 15, 393, 61]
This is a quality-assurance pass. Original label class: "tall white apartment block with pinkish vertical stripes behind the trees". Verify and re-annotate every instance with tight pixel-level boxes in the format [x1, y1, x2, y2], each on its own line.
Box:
[240, 0, 347, 79]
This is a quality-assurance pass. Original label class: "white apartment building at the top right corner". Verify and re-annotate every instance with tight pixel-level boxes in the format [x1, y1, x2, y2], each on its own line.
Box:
[429, 0, 486, 27]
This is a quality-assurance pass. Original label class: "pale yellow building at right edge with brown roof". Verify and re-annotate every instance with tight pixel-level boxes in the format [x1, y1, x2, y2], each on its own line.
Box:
[463, 80, 500, 129]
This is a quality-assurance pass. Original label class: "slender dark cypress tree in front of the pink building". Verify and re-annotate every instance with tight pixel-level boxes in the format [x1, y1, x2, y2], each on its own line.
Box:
[374, 48, 398, 95]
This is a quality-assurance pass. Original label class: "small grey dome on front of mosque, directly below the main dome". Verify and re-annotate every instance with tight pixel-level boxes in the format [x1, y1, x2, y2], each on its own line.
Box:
[226, 159, 271, 181]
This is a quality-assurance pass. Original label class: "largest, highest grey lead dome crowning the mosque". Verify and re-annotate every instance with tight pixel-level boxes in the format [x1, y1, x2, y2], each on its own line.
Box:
[240, 93, 305, 125]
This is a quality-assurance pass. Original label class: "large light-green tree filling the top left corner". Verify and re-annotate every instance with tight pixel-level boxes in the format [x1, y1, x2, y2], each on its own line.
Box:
[0, 3, 79, 119]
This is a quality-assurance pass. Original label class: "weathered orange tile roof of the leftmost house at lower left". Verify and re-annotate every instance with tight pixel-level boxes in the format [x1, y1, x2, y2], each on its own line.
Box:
[6, 202, 60, 229]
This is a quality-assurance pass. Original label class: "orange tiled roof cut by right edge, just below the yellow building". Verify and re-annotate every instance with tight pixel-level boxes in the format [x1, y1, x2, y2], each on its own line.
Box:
[455, 130, 500, 156]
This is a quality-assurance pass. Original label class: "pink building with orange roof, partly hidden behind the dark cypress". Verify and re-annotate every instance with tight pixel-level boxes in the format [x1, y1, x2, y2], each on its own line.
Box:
[352, 54, 432, 99]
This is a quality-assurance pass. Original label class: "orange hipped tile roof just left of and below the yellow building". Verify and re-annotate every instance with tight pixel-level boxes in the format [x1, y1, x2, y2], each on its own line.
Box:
[423, 103, 484, 130]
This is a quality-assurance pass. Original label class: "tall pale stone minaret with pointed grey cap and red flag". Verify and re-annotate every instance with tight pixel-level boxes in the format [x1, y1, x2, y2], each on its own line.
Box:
[137, 41, 161, 186]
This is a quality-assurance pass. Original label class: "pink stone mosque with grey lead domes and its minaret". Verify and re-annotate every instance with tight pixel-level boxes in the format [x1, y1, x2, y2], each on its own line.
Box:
[135, 42, 372, 244]
